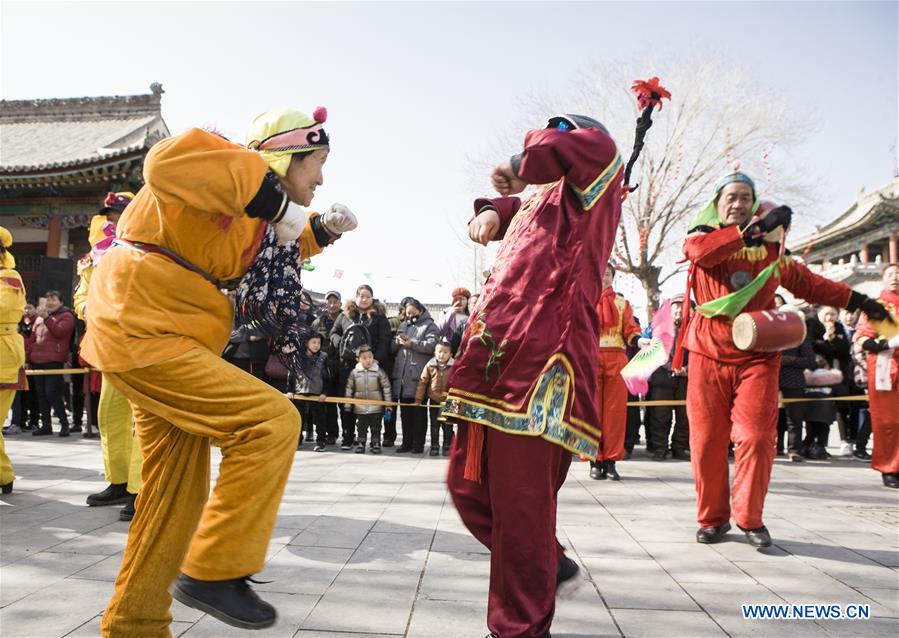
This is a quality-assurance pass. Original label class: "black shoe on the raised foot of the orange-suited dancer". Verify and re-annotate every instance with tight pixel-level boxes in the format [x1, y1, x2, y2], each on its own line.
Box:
[171, 574, 278, 629]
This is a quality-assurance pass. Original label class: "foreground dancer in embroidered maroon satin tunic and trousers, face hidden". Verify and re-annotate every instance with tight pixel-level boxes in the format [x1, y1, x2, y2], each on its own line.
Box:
[442, 80, 664, 638]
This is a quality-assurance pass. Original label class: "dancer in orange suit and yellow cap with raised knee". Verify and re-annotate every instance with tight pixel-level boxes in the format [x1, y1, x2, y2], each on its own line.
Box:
[82, 108, 356, 638]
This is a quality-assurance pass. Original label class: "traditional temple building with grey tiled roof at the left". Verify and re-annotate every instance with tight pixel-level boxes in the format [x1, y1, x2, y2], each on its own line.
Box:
[0, 83, 169, 298]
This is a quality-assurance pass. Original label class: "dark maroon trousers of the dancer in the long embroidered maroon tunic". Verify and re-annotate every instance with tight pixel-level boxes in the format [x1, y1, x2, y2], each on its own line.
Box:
[447, 422, 571, 638]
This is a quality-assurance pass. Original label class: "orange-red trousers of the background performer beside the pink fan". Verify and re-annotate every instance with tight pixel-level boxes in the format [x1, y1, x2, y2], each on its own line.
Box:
[596, 348, 627, 461]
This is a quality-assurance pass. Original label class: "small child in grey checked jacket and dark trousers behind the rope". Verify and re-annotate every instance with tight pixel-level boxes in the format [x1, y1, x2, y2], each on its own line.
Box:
[345, 345, 393, 454]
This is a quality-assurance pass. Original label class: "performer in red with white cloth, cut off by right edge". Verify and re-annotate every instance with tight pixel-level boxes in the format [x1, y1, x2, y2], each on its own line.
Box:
[855, 264, 899, 489]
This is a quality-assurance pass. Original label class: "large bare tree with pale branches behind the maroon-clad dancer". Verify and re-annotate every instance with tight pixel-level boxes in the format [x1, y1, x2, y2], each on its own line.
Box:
[486, 60, 810, 309]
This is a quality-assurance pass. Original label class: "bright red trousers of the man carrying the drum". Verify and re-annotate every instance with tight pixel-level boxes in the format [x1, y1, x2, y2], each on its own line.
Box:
[687, 352, 780, 529]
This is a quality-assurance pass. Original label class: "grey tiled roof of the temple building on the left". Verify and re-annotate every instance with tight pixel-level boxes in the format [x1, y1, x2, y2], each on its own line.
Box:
[0, 85, 169, 177]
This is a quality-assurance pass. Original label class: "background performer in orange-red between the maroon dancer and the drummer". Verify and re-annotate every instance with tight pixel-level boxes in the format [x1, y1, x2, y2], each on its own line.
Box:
[590, 282, 640, 481]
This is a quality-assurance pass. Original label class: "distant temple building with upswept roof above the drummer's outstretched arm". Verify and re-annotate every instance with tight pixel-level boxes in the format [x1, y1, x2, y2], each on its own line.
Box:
[788, 177, 899, 296]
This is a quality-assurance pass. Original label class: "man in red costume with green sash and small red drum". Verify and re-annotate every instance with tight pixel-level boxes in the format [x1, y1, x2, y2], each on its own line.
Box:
[672, 172, 887, 547]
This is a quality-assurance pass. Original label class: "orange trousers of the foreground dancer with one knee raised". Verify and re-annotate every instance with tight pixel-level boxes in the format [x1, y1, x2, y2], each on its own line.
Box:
[100, 348, 300, 638]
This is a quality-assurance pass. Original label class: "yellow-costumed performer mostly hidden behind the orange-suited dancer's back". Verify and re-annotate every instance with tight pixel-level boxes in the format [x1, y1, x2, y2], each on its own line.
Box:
[72, 192, 142, 521]
